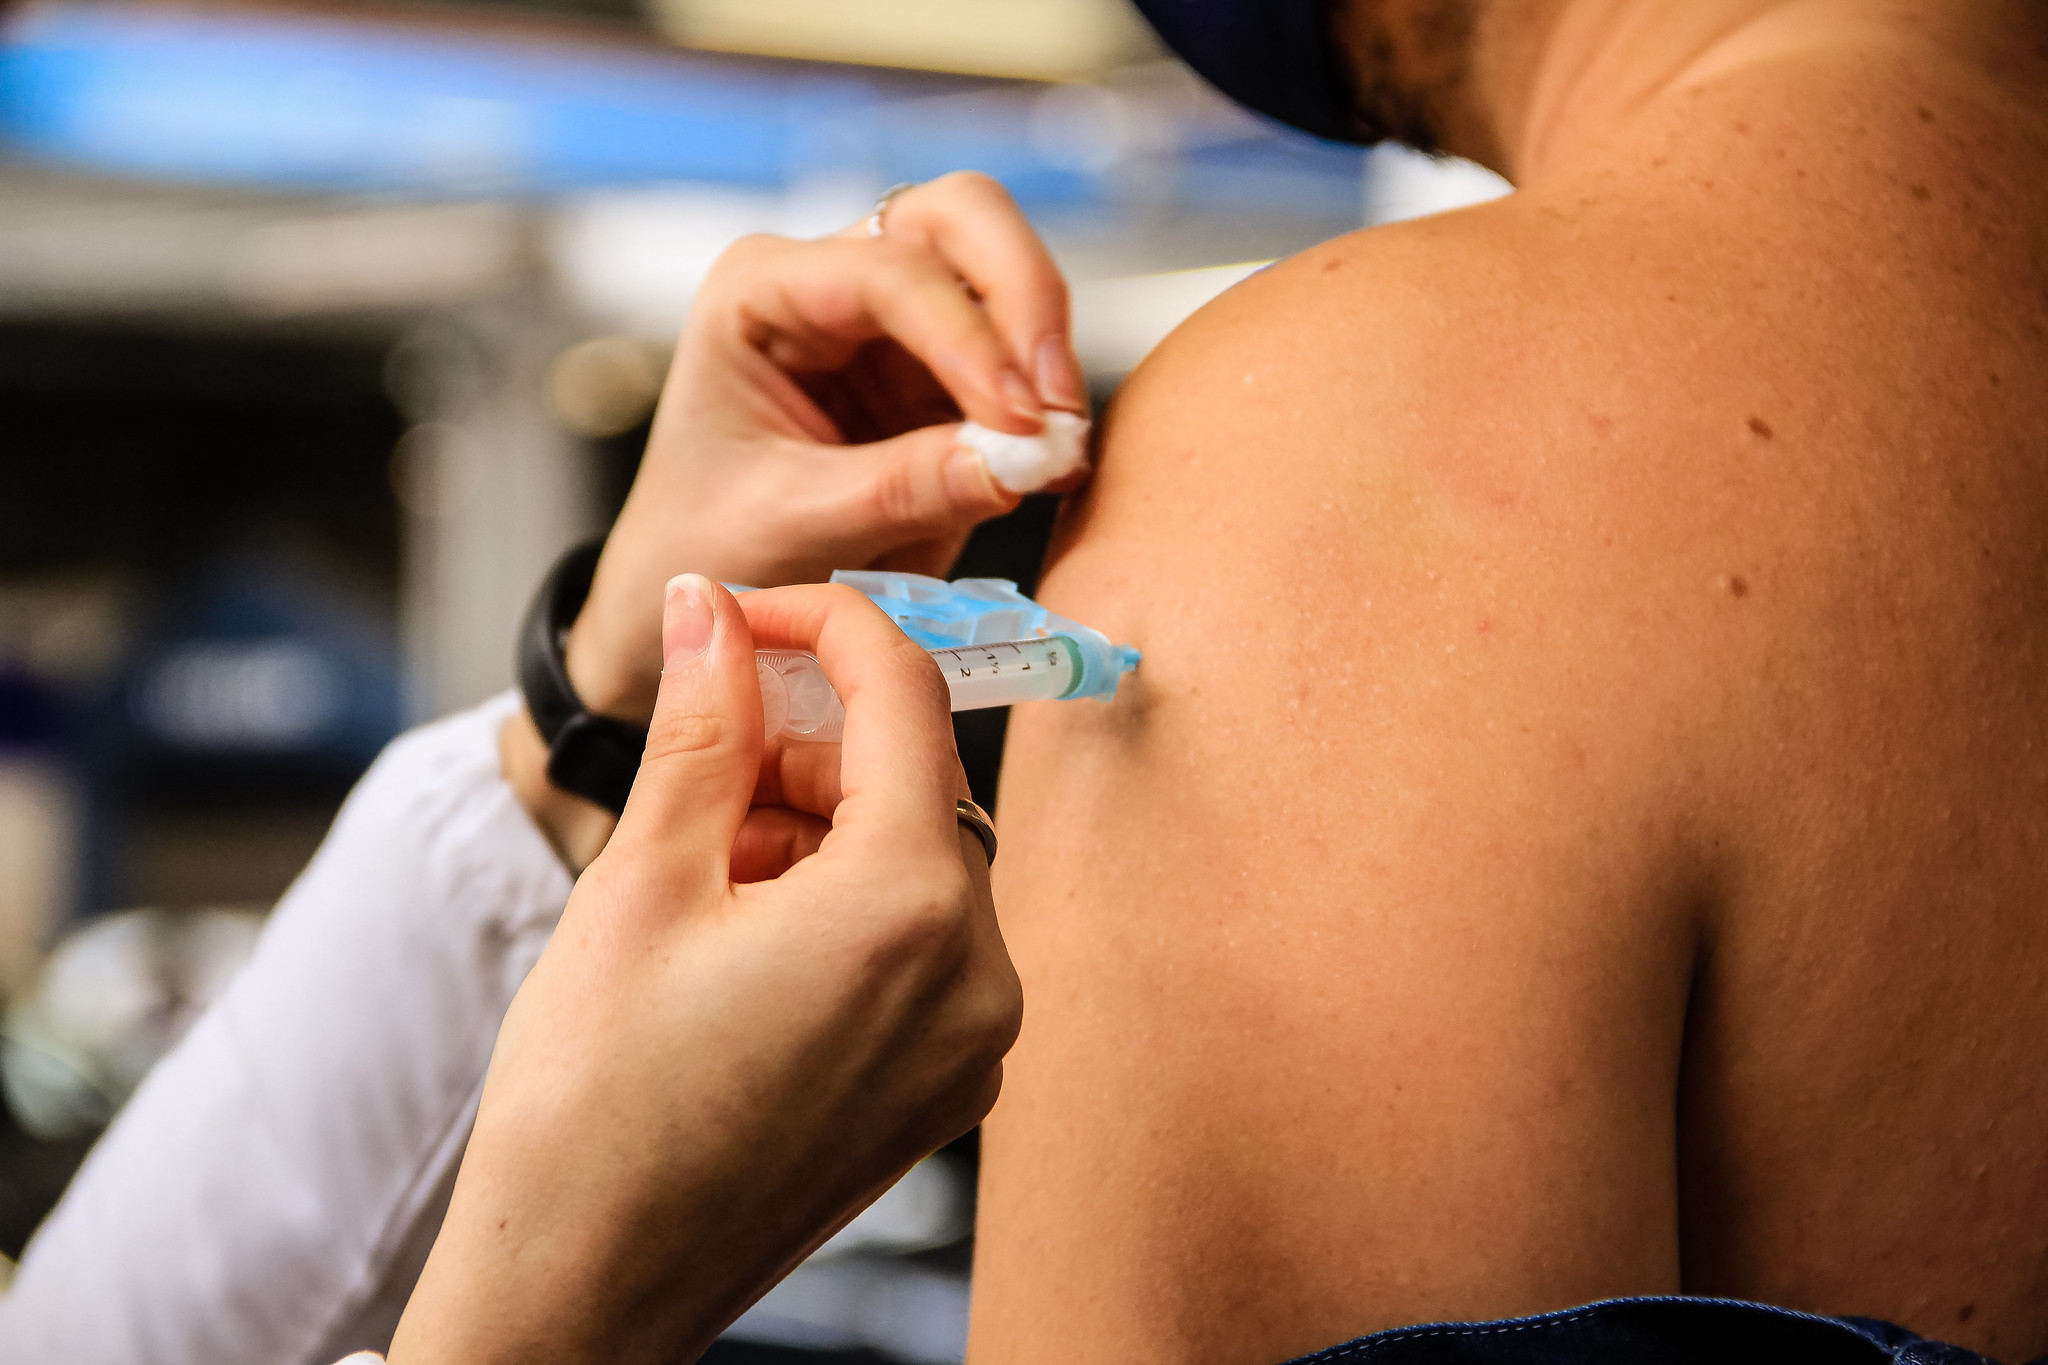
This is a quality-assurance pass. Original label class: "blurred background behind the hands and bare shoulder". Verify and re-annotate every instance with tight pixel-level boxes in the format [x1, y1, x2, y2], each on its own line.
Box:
[0, 0, 1505, 1363]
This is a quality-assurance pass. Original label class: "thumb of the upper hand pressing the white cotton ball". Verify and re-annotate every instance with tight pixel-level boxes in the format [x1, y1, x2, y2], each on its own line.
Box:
[813, 422, 1018, 557]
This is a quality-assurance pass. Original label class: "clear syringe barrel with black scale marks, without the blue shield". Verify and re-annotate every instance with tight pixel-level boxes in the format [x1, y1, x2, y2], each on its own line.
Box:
[754, 634, 1137, 743]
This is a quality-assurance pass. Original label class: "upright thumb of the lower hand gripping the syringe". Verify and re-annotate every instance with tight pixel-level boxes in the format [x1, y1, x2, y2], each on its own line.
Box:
[614, 573, 762, 882]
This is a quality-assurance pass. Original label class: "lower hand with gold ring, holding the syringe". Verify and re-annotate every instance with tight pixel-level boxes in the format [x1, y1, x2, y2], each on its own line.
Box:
[391, 577, 1022, 1365]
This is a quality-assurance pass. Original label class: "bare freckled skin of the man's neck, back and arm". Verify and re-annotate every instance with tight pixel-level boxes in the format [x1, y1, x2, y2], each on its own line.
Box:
[971, 0, 2048, 1365]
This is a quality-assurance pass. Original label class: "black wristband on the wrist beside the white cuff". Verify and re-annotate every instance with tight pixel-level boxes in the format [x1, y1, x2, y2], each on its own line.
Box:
[518, 540, 647, 812]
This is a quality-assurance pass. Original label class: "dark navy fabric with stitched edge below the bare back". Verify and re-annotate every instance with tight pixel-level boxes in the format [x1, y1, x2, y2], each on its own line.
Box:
[1290, 1297, 2048, 1365]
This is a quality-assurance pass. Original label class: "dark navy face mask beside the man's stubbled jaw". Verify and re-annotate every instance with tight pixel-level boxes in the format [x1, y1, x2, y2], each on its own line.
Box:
[1135, 0, 1366, 141]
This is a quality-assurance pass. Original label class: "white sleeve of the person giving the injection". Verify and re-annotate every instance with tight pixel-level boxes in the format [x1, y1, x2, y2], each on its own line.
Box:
[0, 698, 569, 1365]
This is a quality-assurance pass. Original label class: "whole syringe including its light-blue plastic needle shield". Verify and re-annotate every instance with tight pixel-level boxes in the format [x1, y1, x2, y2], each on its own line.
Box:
[754, 569, 1139, 741]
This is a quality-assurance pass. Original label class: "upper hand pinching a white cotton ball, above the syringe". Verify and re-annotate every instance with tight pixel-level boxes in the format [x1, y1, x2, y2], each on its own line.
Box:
[567, 172, 1087, 722]
